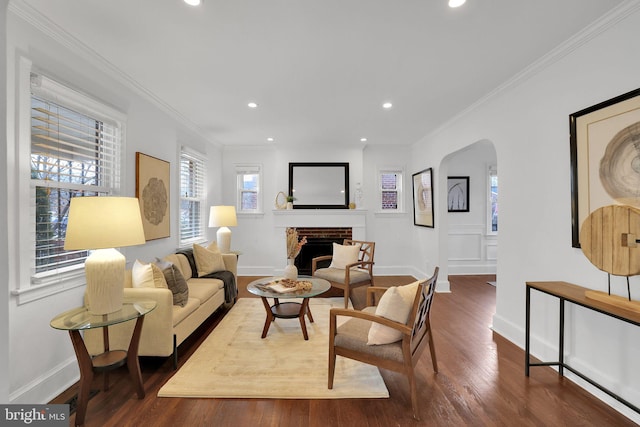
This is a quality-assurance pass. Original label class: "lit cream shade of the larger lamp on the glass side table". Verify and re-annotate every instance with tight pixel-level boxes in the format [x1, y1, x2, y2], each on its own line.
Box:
[64, 197, 145, 250]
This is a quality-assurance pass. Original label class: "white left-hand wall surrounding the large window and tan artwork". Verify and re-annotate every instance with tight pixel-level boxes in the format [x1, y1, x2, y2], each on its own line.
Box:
[0, 9, 221, 403]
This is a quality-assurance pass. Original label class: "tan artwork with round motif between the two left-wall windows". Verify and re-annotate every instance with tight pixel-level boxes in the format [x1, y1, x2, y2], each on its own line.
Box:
[136, 152, 171, 240]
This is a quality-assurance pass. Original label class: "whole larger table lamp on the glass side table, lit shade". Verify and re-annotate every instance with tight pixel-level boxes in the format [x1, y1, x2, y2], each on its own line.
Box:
[64, 197, 145, 314]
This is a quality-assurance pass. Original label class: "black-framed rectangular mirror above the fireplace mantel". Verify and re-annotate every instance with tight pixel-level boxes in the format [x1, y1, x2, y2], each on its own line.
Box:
[289, 163, 349, 209]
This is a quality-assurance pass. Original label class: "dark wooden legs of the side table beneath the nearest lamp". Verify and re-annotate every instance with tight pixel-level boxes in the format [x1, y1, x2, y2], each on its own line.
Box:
[69, 316, 145, 426]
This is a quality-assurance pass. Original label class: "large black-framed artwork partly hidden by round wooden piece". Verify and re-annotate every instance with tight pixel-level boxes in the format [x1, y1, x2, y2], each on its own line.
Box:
[569, 89, 640, 248]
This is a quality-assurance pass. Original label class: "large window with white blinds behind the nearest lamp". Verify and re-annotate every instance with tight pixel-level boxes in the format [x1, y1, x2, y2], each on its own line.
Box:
[29, 74, 123, 285]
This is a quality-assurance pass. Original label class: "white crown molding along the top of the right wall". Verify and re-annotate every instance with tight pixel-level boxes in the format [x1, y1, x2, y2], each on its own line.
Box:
[420, 0, 640, 140]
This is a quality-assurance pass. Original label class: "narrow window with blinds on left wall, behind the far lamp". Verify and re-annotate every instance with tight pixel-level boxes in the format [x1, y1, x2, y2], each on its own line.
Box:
[180, 147, 206, 246]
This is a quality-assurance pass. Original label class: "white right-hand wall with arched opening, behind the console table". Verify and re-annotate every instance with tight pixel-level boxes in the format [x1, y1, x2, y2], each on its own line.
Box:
[412, 1, 640, 421]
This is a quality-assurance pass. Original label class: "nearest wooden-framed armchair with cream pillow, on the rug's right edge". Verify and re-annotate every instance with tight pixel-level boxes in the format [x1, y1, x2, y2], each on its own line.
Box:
[328, 267, 439, 419]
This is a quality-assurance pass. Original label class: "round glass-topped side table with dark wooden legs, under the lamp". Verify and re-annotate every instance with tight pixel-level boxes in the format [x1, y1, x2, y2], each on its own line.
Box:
[50, 301, 156, 426]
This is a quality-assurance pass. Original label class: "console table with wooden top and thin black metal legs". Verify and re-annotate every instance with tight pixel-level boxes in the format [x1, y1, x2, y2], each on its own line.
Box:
[524, 282, 640, 413]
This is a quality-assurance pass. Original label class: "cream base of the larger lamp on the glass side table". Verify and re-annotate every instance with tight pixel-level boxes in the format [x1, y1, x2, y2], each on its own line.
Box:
[84, 249, 126, 314]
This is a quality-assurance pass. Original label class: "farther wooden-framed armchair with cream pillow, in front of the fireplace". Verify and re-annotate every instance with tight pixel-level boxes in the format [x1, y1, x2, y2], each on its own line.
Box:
[311, 240, 376, 308]
